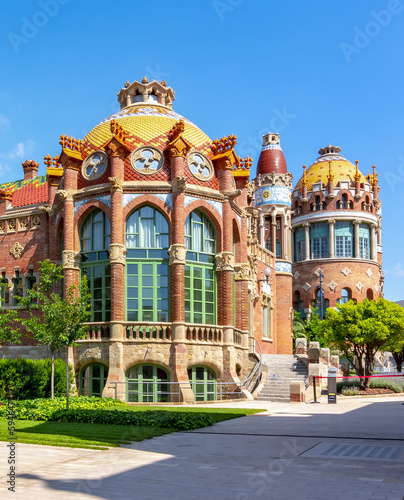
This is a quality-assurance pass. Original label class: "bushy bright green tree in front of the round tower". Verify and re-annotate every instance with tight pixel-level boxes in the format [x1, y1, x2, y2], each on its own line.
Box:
[319, 298, 404, 390]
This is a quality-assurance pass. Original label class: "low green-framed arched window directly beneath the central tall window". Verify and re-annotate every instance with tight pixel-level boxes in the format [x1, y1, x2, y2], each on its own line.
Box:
[126, 365, 170, 403]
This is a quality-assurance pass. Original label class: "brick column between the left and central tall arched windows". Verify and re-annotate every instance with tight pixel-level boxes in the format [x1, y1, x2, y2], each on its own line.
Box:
[109, 156, 126, 340]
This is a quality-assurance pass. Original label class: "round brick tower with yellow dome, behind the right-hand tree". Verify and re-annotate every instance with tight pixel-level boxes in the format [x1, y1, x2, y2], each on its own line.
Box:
[292, 145, 384, 317]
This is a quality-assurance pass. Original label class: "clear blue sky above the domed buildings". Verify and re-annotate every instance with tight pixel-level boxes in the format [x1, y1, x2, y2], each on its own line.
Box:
[0, 0, 404, 300]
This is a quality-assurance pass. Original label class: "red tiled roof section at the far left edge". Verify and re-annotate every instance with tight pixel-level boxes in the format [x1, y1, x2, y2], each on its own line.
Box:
[0, 175, 49, 208]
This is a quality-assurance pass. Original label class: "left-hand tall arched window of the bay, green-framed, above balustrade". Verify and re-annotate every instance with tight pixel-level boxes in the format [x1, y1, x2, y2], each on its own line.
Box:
[80, 208, 111, 321]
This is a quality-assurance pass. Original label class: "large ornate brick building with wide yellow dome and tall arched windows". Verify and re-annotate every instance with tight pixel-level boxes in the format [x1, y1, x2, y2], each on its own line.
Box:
[0, 79, 294, 401]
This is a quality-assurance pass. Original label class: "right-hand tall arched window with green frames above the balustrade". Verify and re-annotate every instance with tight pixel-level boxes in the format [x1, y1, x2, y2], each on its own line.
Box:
[185, 210, 216, 325]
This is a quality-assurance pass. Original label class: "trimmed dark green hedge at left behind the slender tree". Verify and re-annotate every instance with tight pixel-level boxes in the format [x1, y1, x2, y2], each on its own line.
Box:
[0, 359, 73, 400]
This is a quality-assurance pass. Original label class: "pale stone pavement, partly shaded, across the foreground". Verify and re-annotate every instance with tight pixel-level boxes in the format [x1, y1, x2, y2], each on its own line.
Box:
[0, 396, 404, 500]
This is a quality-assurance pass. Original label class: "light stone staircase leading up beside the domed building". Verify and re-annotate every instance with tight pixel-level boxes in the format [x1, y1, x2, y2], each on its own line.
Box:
[256, 354, 308, 403]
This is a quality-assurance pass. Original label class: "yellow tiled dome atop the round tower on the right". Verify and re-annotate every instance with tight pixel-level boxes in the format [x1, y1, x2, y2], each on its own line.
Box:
[296, 145, 368, 191]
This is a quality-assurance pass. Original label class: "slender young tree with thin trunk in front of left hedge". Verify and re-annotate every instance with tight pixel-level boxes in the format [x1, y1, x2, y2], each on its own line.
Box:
[19, 259, 91, 409]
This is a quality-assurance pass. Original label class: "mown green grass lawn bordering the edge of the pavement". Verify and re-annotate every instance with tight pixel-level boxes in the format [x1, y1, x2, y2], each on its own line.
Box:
[0, 405, 265, 450]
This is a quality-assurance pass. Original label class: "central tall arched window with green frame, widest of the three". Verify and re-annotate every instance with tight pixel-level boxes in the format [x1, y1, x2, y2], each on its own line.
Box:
[126, 205, 170, 322]
